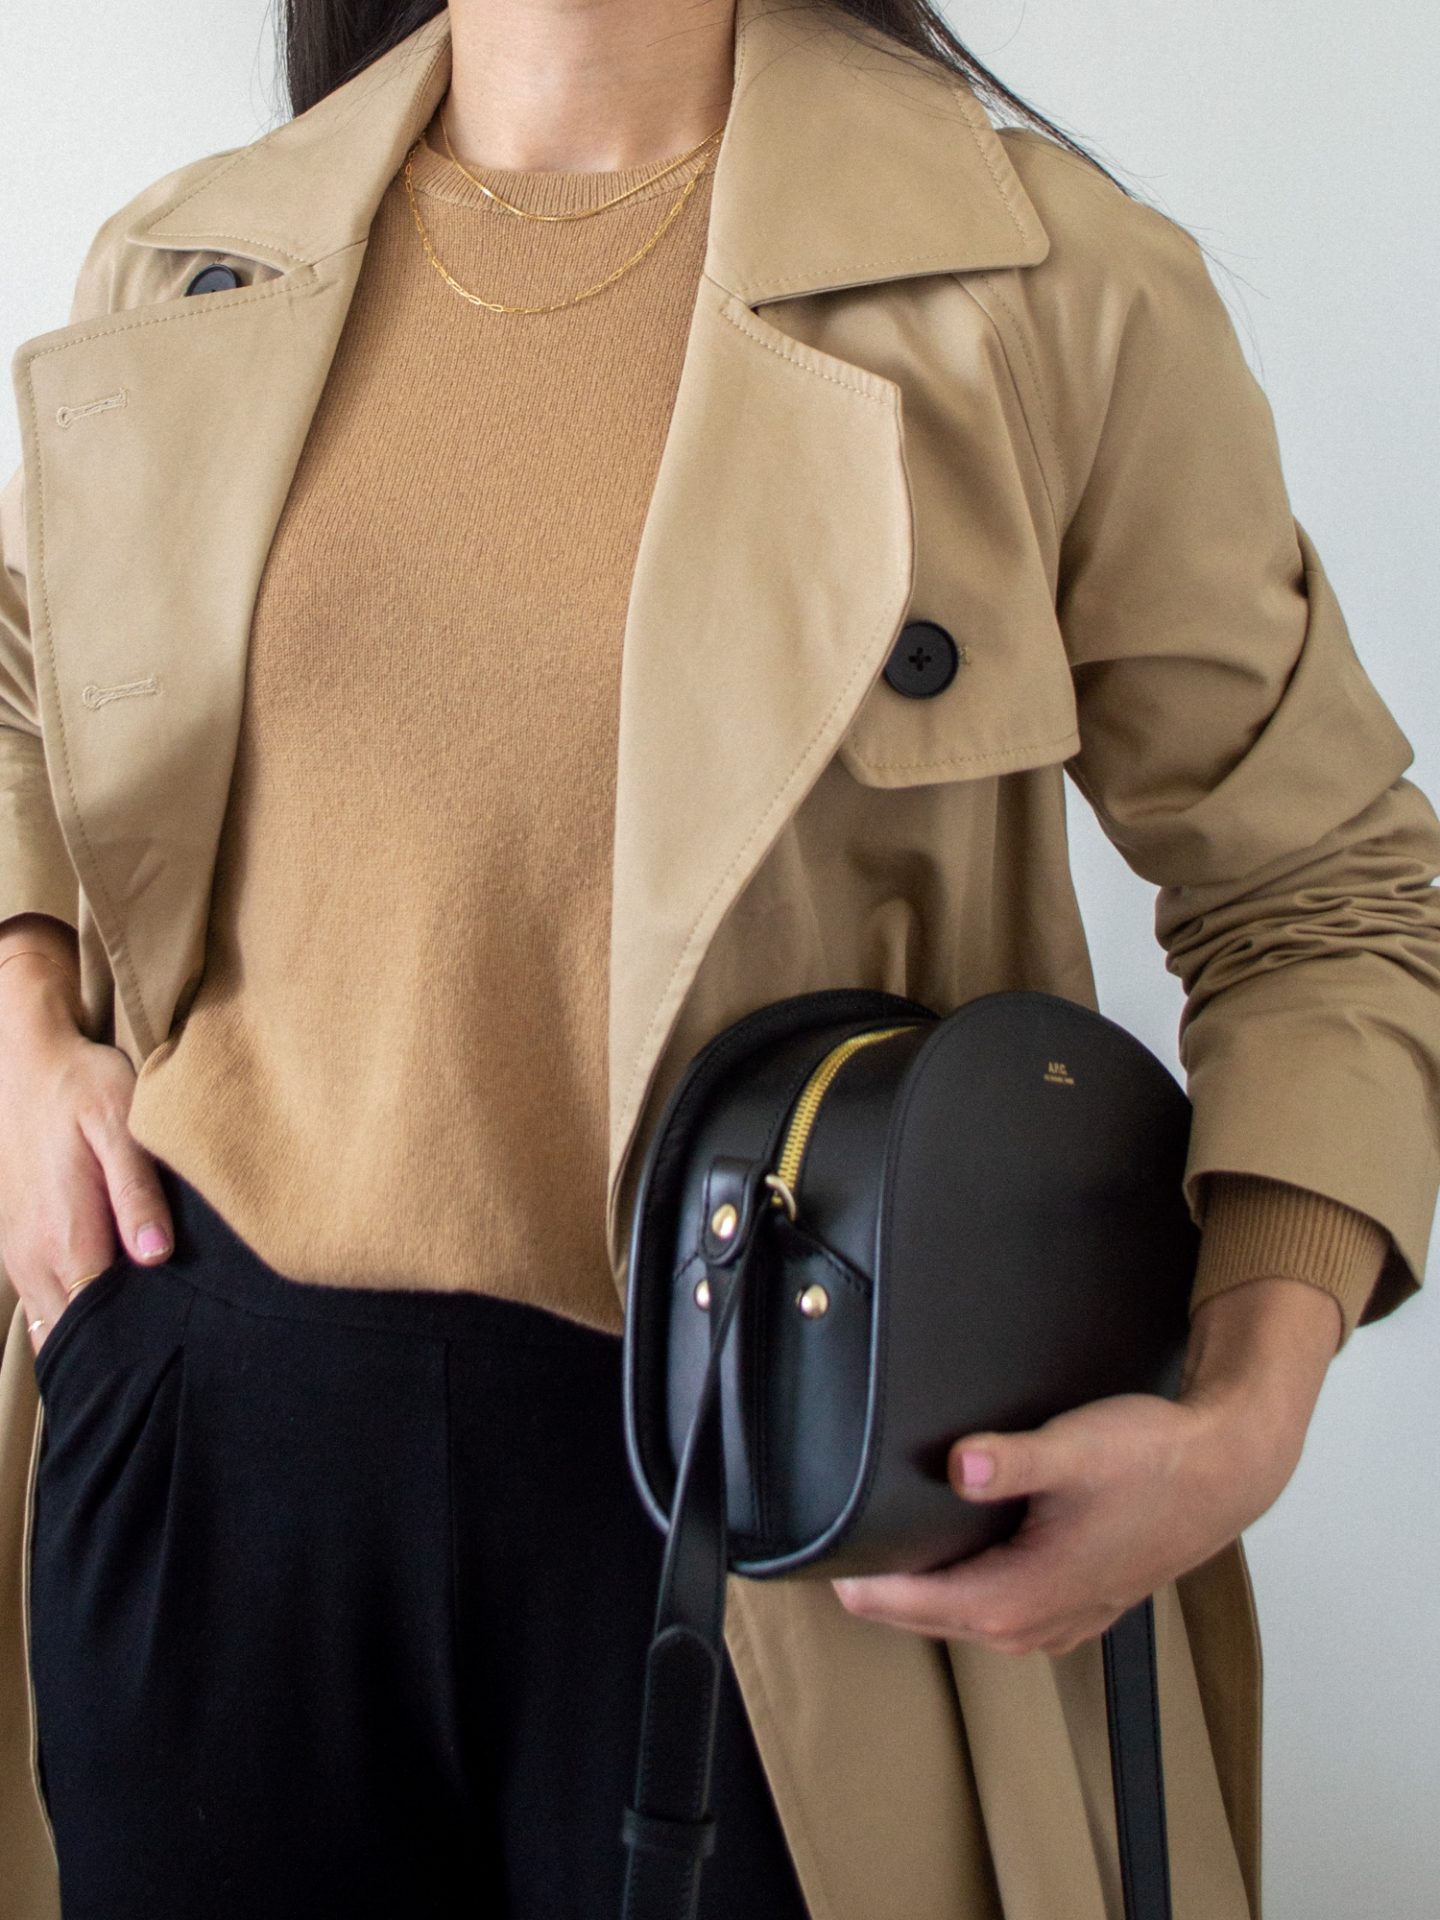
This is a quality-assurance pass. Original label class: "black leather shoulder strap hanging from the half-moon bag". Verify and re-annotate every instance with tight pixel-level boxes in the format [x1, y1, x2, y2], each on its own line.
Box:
[620, 1164, 1171, 1920]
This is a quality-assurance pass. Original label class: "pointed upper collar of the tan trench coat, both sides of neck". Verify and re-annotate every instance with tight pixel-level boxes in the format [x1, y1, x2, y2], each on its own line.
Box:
[127, 0, 1048, 307]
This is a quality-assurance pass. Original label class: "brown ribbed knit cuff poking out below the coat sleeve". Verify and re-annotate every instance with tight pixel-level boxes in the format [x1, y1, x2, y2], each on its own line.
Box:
[1190, 1173, 1390, 1352]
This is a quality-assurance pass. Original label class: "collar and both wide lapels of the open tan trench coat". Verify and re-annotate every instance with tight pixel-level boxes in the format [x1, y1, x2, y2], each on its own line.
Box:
[13, 0, 1048, 1288]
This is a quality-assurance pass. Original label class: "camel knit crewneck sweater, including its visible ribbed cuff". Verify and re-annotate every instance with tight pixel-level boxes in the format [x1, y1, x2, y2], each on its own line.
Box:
[131, 112, 1386, 1336]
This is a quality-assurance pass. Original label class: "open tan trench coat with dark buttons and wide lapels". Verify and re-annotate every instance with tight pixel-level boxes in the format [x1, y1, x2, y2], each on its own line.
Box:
[0, 0, 1440, 1920]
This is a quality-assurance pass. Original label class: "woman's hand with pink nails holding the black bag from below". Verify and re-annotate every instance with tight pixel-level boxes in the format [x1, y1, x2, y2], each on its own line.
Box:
[833, 1279, 1340, 1653]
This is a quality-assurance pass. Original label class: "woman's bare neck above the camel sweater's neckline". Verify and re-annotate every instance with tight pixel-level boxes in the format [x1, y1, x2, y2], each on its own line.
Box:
[440, 0, 735, 171]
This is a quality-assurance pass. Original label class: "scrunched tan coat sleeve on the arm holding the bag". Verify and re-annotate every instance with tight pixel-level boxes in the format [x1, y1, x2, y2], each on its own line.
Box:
[1056, 198, 1440, 1321]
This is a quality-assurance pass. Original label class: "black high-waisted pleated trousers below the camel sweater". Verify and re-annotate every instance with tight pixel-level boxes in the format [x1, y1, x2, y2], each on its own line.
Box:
[29, 1164, 806, 1920]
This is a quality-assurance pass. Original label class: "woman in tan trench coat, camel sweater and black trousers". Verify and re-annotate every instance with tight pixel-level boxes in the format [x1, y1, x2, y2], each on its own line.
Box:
[0, 0, 1440, 1920]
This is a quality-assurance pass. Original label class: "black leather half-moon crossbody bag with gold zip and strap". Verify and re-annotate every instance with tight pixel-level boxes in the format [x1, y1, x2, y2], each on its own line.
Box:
[620, 989, 1200, 1920]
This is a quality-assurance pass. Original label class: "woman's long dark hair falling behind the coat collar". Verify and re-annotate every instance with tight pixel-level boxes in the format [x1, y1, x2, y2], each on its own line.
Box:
[276, 0, 1131, 194]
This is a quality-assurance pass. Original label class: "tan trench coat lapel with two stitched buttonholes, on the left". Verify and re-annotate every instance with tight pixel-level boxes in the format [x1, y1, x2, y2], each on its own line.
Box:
[17, 252, 372, 1056]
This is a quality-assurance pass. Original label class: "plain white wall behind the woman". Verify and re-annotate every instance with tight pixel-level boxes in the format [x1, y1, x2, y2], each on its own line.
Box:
[0, 0, 1440, 1920]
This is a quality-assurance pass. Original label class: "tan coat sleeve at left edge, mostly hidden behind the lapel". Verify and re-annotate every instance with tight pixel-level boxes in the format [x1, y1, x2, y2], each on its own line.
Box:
[0, 219, 115, 927]
